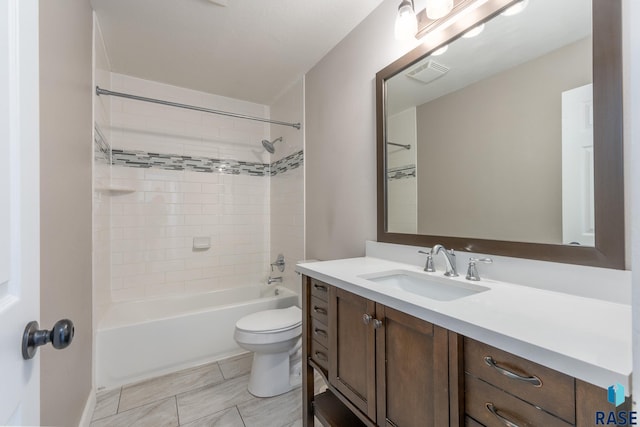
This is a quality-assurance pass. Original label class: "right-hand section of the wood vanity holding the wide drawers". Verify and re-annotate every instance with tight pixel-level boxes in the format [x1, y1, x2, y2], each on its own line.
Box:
[463, 338, 631, 427]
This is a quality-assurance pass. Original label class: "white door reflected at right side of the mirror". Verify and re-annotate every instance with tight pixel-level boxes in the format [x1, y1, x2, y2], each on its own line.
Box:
[562, 84, 595, 246]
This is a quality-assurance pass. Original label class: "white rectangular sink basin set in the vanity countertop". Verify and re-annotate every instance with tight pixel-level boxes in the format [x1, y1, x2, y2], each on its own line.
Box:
[360, 270, 489, 301]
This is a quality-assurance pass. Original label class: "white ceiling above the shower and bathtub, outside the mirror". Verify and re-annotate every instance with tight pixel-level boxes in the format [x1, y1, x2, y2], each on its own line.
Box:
[91, 0, 389, 105]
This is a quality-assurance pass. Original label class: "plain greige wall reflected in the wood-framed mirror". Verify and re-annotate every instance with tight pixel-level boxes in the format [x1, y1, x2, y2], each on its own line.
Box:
[416, 37, 592, 244]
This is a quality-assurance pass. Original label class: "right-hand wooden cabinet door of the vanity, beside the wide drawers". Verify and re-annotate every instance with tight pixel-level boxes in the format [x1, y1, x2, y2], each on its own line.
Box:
[376, 304, 449, 427]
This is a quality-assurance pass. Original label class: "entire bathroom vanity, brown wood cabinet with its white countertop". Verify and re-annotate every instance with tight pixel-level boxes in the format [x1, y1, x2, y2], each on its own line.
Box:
[298, 257, 631, 427]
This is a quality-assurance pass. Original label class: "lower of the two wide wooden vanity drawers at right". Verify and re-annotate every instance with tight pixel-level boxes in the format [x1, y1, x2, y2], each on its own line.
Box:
[464, 374, 571, 427]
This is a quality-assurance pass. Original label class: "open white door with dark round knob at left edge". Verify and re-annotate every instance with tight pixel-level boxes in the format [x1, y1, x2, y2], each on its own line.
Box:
[0, 0, 40, 425]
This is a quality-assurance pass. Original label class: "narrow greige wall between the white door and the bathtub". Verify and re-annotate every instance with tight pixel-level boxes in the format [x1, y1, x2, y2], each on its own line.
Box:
[40, 0, 93, 426]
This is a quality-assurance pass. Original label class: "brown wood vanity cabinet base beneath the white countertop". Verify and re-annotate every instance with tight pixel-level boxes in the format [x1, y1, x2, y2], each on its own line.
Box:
[303, 277, 631, 427]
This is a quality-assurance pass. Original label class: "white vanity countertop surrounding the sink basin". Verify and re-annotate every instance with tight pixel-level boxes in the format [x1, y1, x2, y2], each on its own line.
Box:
[296, 257, 632, 394]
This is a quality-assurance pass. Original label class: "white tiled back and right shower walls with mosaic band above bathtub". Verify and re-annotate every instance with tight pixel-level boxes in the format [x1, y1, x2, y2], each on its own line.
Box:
[97, 73, 304, 303]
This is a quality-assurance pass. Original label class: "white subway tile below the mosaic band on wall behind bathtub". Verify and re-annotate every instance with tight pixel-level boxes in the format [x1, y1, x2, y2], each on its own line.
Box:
[111, 166, 270, 301]
